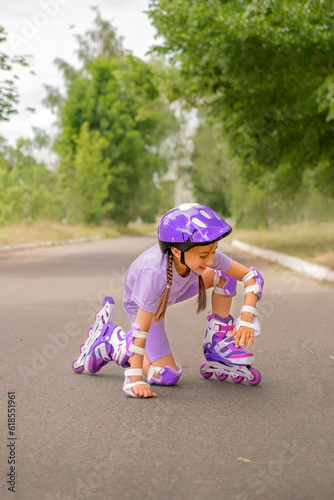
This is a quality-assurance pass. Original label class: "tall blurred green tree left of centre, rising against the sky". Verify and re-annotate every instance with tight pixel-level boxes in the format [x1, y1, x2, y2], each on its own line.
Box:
[48, 8, 178, 224]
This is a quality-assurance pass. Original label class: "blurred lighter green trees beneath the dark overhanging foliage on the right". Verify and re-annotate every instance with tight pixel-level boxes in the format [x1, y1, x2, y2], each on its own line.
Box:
[188, 115, 334, 228]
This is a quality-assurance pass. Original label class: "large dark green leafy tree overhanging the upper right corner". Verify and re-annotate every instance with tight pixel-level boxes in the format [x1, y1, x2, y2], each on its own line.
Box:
[150, 0, 334, 196]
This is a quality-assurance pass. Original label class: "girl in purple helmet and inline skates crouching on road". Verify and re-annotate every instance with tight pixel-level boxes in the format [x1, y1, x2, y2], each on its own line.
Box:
[74, 204, 263, 398]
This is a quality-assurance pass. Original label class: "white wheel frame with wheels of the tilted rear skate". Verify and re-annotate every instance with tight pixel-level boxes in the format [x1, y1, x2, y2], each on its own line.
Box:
[72, 297, 125, 373]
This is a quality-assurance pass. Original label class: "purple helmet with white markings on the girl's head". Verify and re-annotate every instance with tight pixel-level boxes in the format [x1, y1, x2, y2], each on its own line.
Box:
[158, 203, 232, 253]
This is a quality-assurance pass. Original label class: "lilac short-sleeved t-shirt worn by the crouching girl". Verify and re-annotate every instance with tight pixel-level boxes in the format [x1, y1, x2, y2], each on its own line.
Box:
[123, 244, 232, 321]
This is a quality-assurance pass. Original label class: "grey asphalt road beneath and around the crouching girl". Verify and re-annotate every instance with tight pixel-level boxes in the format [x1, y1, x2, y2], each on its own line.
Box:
[0, 237, 334, 500]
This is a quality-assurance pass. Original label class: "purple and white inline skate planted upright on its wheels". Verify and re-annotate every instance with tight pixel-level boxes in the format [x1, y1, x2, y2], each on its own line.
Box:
[200, 314, 261, 385]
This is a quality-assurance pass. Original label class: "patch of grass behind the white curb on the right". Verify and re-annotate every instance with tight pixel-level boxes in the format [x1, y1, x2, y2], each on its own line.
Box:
[231, 222, 334, 269]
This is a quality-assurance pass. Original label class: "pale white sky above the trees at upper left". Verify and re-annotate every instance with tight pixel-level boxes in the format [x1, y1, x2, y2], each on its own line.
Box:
[0, 0, 156, 145]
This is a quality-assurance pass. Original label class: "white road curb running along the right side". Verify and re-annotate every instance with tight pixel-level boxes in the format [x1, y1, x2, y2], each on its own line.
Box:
[231, 240, 334, 282]
